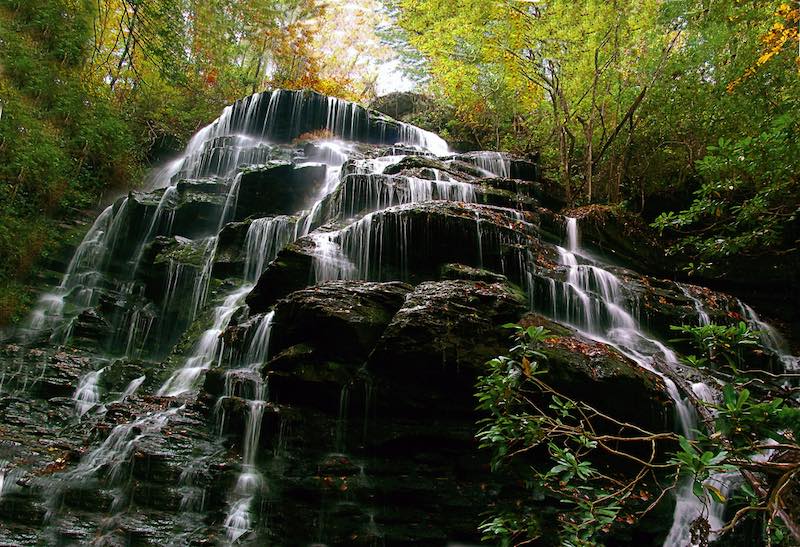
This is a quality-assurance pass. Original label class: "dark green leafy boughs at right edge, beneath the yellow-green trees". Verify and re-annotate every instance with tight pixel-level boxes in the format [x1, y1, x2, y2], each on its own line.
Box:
[654, 115, 800, 276]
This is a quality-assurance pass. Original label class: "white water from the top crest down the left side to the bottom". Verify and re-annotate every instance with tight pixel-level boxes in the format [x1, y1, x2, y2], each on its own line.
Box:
[12, 91, 456, 542]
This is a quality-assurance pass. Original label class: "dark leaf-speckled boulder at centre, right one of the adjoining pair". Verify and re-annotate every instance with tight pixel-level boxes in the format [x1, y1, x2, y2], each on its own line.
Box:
[367, 281, 526, 415]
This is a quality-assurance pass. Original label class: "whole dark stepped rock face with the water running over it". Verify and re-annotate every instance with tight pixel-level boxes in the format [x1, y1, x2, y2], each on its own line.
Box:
[0, 91, 790, 545]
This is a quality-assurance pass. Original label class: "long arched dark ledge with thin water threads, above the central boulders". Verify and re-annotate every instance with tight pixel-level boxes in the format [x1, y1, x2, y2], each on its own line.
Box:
[247, 201, 558, 312]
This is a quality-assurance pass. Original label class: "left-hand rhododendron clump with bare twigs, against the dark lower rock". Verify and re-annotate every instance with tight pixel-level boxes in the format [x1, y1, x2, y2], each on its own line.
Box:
[476, 324, 675, 546]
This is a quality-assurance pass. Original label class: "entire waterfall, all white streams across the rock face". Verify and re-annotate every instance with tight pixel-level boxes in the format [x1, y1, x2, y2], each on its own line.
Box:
[21, 90, 797, 546]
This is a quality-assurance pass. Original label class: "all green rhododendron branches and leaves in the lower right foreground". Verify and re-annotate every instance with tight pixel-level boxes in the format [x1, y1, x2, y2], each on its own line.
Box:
[476, 324, 800, 546]
